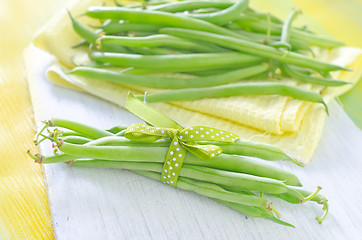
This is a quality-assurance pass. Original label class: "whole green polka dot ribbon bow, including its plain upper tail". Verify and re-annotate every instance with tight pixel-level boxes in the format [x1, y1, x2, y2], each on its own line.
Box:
[124, 93, 238, 187]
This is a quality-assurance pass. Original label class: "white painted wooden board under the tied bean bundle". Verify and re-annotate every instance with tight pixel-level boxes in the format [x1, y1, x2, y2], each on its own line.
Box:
[25, 47, 362, 240]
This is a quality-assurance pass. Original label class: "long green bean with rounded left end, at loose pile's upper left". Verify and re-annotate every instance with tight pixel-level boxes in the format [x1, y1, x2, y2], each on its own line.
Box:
[86, 7, 250, 38]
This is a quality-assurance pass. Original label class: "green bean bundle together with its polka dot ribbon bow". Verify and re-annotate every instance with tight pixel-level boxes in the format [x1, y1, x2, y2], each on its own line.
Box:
[28, 94, 328, 227]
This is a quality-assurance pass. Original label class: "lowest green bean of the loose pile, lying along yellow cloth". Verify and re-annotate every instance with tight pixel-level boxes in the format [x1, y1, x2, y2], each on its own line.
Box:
[138, 82, 328, 114]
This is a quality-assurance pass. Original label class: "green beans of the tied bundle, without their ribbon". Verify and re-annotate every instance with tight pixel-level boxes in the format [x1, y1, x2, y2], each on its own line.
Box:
[28, 119, 328, 227]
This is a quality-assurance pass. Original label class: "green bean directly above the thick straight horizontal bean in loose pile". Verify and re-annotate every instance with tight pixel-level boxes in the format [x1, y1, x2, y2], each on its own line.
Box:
[98, 34, 226, 53]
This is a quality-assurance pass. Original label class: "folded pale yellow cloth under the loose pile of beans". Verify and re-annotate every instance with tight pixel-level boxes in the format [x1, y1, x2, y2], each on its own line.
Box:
[34, 0, 362, 164]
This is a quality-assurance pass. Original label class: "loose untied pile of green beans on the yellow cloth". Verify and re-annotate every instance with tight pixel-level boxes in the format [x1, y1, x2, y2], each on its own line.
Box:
[69, 0, 347, 110]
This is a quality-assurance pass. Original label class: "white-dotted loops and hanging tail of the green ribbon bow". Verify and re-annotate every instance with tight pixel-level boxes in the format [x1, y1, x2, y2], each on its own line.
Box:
[125, 124, 238, 187]
